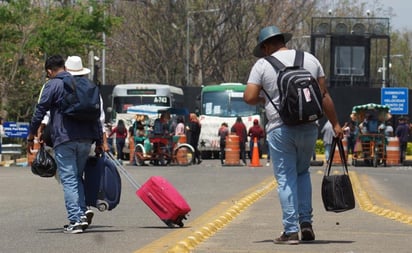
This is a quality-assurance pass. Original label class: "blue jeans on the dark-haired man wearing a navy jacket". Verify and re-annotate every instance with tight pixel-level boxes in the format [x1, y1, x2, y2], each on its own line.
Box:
[54, 141, 91, 222]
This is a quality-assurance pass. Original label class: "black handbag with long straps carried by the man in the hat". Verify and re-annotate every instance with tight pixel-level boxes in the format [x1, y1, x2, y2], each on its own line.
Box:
[322, 137, 355, 213]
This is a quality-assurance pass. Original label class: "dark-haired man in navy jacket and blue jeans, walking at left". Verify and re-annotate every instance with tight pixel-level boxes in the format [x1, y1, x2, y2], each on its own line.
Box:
[27, 55, 103, 234]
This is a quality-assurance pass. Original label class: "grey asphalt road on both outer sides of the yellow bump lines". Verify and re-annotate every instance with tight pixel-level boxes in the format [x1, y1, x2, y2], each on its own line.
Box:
[0, 160, 412, 253]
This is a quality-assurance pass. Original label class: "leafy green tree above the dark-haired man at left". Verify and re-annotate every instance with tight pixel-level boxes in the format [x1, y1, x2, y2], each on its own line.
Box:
[0, 0, 120, 121]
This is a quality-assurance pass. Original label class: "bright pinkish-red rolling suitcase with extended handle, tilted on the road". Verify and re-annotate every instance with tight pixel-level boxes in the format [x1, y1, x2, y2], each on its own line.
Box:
[105, 153, 191, 228]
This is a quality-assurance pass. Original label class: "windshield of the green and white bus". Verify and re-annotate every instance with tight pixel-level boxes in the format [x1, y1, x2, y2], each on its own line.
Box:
[202, 90, 258, 117]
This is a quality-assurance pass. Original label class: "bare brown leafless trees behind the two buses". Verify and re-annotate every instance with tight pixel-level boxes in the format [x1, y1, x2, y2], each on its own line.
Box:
[107, 0, 314, 86]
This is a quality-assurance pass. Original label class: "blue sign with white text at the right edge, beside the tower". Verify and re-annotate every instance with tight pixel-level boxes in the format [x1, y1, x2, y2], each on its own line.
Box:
[381, 88, 409, 115]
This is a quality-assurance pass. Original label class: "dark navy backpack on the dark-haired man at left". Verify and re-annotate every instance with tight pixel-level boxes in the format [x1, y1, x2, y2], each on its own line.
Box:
[58, 76, 100, 121]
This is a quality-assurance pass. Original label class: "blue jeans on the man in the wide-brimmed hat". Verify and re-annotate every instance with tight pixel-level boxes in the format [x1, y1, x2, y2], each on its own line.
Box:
[267, 124, 318, 234]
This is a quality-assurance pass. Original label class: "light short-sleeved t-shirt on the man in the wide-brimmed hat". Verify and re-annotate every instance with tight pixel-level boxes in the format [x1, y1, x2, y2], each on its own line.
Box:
[248, 50, 325, 132]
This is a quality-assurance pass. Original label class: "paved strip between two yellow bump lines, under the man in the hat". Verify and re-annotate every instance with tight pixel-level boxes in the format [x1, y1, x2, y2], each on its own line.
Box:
[173, 168, 412, 253]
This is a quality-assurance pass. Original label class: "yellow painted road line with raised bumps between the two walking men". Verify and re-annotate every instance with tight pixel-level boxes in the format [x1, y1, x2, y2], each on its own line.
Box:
[134, 176, 276, 253]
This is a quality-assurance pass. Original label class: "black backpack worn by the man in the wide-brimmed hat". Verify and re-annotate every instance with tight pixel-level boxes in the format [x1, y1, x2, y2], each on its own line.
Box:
[263, 51, 323, 125]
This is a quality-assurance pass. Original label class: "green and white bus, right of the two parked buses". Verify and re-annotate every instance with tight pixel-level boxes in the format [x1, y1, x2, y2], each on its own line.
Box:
[199, 83, 264, 158]
